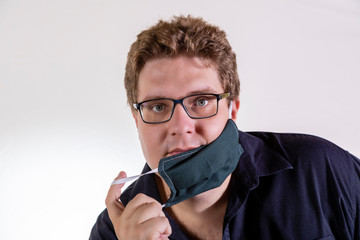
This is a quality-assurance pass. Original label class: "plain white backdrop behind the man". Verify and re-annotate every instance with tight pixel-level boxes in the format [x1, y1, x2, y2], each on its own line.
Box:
[0, 0, 360, 240]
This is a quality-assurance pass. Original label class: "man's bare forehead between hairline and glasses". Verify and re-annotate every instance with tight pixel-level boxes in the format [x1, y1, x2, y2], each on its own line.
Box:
[137, 56, 223, 102]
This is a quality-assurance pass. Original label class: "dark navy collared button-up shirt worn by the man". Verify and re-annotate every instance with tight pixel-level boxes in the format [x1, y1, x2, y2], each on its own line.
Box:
[90, 131, 360, 240]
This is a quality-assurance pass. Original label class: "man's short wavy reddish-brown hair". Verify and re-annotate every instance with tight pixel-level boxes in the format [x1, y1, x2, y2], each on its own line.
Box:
[124, 16, 240, 105]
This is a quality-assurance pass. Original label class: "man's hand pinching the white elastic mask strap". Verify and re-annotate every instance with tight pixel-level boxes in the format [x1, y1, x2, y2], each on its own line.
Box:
[105, 172, 171, 240]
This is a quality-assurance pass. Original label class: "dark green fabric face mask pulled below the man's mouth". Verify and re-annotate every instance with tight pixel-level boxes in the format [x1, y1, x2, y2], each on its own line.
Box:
[158, 120, 244, 207]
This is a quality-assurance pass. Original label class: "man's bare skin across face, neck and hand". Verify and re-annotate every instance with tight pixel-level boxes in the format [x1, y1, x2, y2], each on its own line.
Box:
[106, 56, 239, 239]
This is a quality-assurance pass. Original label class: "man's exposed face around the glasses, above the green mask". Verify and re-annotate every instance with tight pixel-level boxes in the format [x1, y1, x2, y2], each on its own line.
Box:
[134, 56, 239, 169]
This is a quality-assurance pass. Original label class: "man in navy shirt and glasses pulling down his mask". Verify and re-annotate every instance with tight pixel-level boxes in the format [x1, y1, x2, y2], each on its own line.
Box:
[90, 17, 360, 240]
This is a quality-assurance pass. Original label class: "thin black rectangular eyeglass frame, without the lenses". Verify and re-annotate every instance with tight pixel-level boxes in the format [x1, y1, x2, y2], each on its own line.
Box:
[133, 92, 230, 124]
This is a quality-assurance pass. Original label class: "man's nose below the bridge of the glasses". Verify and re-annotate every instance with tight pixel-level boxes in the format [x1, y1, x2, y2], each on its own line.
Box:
[168, 104, 195, 136]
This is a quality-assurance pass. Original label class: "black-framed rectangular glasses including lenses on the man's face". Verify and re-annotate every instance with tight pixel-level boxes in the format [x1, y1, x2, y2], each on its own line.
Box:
[133, 93, 230, 123]
